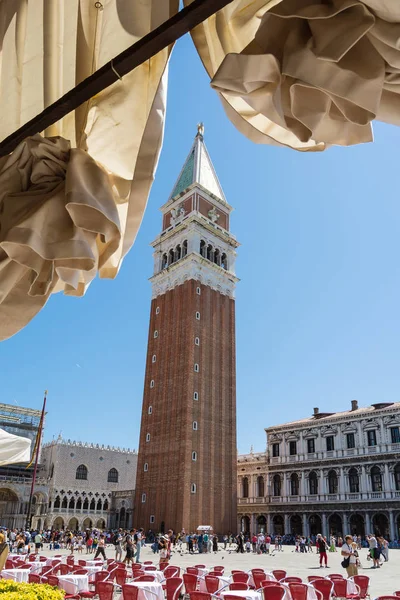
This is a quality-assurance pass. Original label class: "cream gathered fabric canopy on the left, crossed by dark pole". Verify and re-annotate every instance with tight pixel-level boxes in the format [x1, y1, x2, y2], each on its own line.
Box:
[0, 0, 178, 339]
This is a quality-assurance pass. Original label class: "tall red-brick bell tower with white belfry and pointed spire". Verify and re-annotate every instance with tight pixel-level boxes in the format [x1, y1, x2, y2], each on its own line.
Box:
[134, 124, 239, 534]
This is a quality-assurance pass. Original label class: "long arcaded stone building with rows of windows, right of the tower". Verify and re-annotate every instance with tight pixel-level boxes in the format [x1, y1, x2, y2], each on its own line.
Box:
[238, 401, 400, 540]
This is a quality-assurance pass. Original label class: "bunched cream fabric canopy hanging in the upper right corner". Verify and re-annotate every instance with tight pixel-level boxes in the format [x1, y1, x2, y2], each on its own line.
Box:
[186, 0, 400, 151]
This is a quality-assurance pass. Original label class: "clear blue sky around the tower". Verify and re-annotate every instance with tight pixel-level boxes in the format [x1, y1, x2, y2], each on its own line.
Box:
[0, 36, 400, 452]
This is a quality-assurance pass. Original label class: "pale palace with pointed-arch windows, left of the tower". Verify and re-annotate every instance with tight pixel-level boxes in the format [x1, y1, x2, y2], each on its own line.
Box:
[41, 439, 137, 529]
